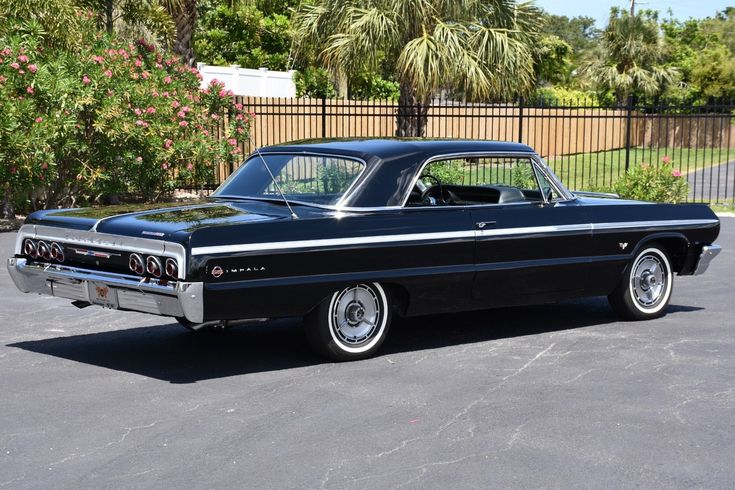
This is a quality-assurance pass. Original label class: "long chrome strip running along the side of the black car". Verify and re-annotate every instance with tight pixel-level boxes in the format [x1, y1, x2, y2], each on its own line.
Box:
[191, 219, 719, 255]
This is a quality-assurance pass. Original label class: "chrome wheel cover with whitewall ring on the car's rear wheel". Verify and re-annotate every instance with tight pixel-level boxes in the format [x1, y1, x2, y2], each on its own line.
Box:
[329, 284, 385, 352]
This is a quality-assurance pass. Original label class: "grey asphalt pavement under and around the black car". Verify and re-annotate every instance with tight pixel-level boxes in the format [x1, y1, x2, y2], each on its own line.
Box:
[0, 218, 735, 489]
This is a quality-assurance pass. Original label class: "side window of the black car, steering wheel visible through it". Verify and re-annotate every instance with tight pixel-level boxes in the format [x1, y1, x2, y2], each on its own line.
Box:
[408, 156, 558, 206]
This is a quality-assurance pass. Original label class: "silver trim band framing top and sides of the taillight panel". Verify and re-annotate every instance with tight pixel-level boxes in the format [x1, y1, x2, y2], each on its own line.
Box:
[15, 224, 186, 279]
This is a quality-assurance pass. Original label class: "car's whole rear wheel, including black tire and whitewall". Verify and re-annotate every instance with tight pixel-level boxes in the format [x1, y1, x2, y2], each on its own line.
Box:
[305, 282, 391, 361]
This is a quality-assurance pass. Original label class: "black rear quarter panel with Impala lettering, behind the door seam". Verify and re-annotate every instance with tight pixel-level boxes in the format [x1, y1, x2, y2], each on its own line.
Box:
[191, 208, 475, 319]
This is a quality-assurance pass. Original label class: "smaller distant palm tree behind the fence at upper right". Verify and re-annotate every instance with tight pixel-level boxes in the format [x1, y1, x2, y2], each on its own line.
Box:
[582, 7, 678, 104]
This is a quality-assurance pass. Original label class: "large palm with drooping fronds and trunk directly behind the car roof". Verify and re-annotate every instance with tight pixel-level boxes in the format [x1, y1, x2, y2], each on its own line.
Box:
[294, 0, 541, 136]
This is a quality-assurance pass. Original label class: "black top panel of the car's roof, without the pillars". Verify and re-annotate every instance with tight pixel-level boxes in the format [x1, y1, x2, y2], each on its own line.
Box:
[260, 138, 533, 161]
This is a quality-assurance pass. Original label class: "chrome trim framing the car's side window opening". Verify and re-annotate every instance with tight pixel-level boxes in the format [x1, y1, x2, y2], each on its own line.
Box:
[401, 151, 575, 209]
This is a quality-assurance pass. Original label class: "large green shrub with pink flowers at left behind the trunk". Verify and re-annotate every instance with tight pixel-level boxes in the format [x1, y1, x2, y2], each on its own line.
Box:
[0, 18, 251, 212]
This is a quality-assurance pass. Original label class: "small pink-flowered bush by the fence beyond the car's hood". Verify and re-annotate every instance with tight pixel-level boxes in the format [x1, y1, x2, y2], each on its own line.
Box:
[615, 156, 689, 204]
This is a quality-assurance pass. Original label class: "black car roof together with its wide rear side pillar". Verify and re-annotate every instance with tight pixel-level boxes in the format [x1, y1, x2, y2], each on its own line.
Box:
[259, 138, 533, 208]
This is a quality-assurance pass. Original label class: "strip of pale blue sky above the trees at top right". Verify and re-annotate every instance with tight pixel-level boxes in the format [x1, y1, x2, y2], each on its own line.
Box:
[536, 0, 735, 28]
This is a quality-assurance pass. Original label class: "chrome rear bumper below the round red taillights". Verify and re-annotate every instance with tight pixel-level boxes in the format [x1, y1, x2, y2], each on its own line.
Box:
[8, 258, 204, 323]
